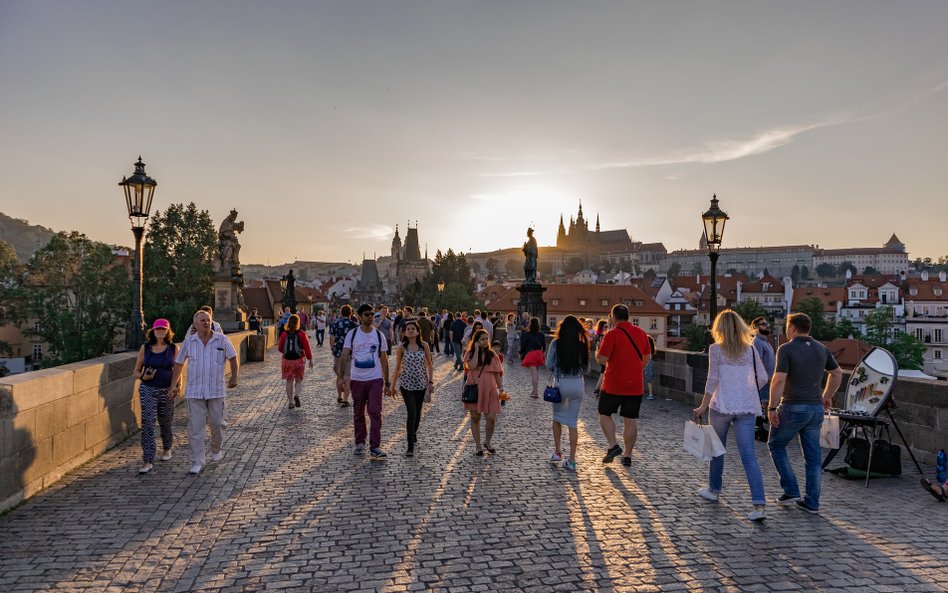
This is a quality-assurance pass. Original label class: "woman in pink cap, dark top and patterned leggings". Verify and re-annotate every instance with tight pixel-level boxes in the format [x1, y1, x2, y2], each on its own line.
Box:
[135, 319, 178, 474]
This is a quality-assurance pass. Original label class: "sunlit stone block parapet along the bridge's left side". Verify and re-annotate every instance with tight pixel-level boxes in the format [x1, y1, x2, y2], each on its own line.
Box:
[0, 328, 276, 511]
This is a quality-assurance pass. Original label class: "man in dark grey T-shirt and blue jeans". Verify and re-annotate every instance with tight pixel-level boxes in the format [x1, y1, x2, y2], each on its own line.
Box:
[767, 313, 843, 514]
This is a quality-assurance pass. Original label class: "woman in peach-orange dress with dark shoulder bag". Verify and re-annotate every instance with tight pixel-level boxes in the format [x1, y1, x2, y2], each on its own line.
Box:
[464, 329, 504, 457]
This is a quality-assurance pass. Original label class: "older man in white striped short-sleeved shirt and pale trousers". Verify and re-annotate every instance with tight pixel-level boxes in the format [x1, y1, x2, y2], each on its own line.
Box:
[171, 311, 240, 474]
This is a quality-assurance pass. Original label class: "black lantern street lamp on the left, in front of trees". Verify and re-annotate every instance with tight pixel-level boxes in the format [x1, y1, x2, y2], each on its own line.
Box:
[119, 155, 158, 350]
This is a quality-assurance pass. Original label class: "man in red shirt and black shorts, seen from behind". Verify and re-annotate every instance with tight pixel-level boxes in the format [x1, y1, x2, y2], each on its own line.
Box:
[596, 305, 652, 466]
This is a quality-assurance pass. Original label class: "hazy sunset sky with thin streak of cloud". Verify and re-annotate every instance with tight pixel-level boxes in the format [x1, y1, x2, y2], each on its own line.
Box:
[0, 0, 948, 264]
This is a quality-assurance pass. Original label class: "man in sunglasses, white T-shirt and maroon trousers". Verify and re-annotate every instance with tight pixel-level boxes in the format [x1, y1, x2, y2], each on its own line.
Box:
[337, 305, 395, 459]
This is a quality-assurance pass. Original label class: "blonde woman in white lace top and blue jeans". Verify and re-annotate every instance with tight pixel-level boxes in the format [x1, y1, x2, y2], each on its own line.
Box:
[694, 310, 767, 521]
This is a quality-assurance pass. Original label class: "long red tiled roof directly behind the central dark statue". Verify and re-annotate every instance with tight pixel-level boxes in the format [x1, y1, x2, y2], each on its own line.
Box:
[491, 284, 669, 316]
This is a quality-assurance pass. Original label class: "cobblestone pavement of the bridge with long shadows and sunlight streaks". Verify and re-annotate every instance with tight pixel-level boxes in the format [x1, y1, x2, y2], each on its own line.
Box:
[0, 348, 948, 592]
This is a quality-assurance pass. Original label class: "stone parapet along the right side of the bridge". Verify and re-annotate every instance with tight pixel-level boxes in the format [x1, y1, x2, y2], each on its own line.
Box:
[654, 350, 948, 465]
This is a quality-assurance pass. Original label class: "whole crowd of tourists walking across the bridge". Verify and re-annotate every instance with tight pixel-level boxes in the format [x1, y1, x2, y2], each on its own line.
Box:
[135, 304, 842, 521]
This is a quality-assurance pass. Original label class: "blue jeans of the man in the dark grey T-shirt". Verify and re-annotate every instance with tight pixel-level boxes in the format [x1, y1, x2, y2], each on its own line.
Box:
[768, 404, 823, 509]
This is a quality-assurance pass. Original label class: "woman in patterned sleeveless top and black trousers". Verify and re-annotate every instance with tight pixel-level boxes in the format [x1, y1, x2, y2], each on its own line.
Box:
[392, 320, 434, 457]
